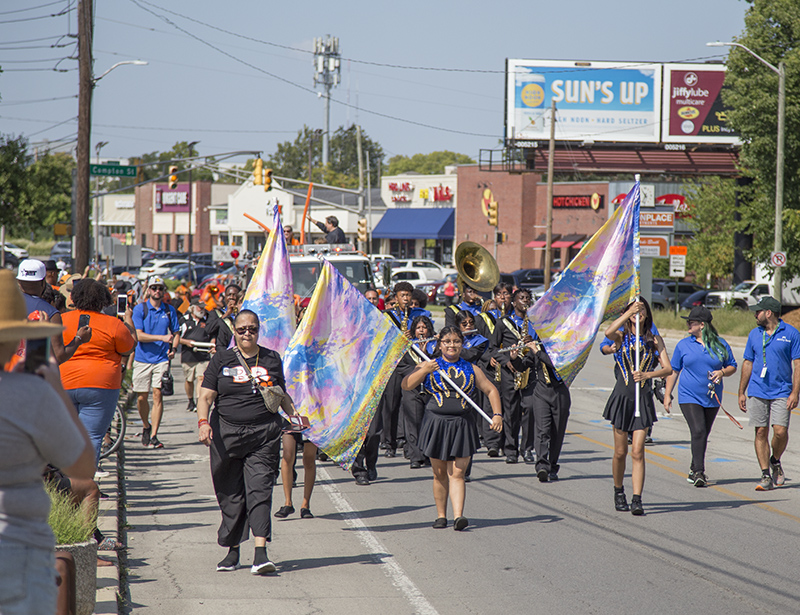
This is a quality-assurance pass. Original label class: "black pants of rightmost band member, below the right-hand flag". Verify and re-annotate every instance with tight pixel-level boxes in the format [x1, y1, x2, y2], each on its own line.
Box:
[522, 381, 571, 473]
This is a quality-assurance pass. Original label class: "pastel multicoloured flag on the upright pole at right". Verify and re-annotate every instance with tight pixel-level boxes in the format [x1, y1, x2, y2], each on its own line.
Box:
[528, 181, 640, 384]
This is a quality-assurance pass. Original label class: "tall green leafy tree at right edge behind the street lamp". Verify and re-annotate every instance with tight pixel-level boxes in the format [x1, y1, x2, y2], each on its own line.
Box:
[723, 0, 800, 279]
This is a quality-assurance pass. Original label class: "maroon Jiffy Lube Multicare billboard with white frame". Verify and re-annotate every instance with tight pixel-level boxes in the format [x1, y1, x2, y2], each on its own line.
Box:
[661, 64, 740, 143]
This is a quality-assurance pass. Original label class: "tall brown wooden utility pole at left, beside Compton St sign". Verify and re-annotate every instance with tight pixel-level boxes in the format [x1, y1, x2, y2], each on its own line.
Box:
[72, 0, 93, 272]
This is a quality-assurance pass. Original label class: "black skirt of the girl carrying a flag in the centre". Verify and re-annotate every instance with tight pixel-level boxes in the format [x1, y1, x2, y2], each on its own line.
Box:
[418, 398, 480, 461]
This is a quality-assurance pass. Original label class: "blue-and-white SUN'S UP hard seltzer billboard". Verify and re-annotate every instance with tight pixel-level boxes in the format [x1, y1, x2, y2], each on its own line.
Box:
[506, 60, 662, 143]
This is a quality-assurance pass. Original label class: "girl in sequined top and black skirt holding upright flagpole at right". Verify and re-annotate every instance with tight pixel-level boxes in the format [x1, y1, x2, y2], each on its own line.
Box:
[603, 300, 672, 516]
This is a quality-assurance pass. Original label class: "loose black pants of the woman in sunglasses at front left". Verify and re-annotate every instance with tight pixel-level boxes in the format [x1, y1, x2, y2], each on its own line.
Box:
[210, 412, 281, 547]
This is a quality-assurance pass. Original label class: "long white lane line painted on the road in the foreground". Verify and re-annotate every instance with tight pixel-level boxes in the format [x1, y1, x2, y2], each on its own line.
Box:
[317, 466, 439, 615]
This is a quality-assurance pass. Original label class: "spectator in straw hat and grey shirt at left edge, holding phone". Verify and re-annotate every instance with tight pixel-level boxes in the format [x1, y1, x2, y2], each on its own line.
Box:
[0, 265, 95, 613]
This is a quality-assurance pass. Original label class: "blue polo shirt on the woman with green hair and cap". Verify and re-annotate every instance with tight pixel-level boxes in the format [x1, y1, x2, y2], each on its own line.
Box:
[672, 335, 736, 408]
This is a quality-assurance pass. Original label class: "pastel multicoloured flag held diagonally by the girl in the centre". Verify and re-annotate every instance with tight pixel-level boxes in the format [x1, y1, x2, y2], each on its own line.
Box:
[283, 261, 410, 470]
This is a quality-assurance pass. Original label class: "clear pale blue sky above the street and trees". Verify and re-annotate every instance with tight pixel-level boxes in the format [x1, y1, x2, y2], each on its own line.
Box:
[0, 0, 747, 165]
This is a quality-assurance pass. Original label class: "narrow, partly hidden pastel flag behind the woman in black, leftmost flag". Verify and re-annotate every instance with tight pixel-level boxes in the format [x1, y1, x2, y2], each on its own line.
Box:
[242, 207, 296, 354]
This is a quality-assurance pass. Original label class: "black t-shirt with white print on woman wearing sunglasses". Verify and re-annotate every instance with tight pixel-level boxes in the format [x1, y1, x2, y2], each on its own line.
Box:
[203, 347, 286, 425]
